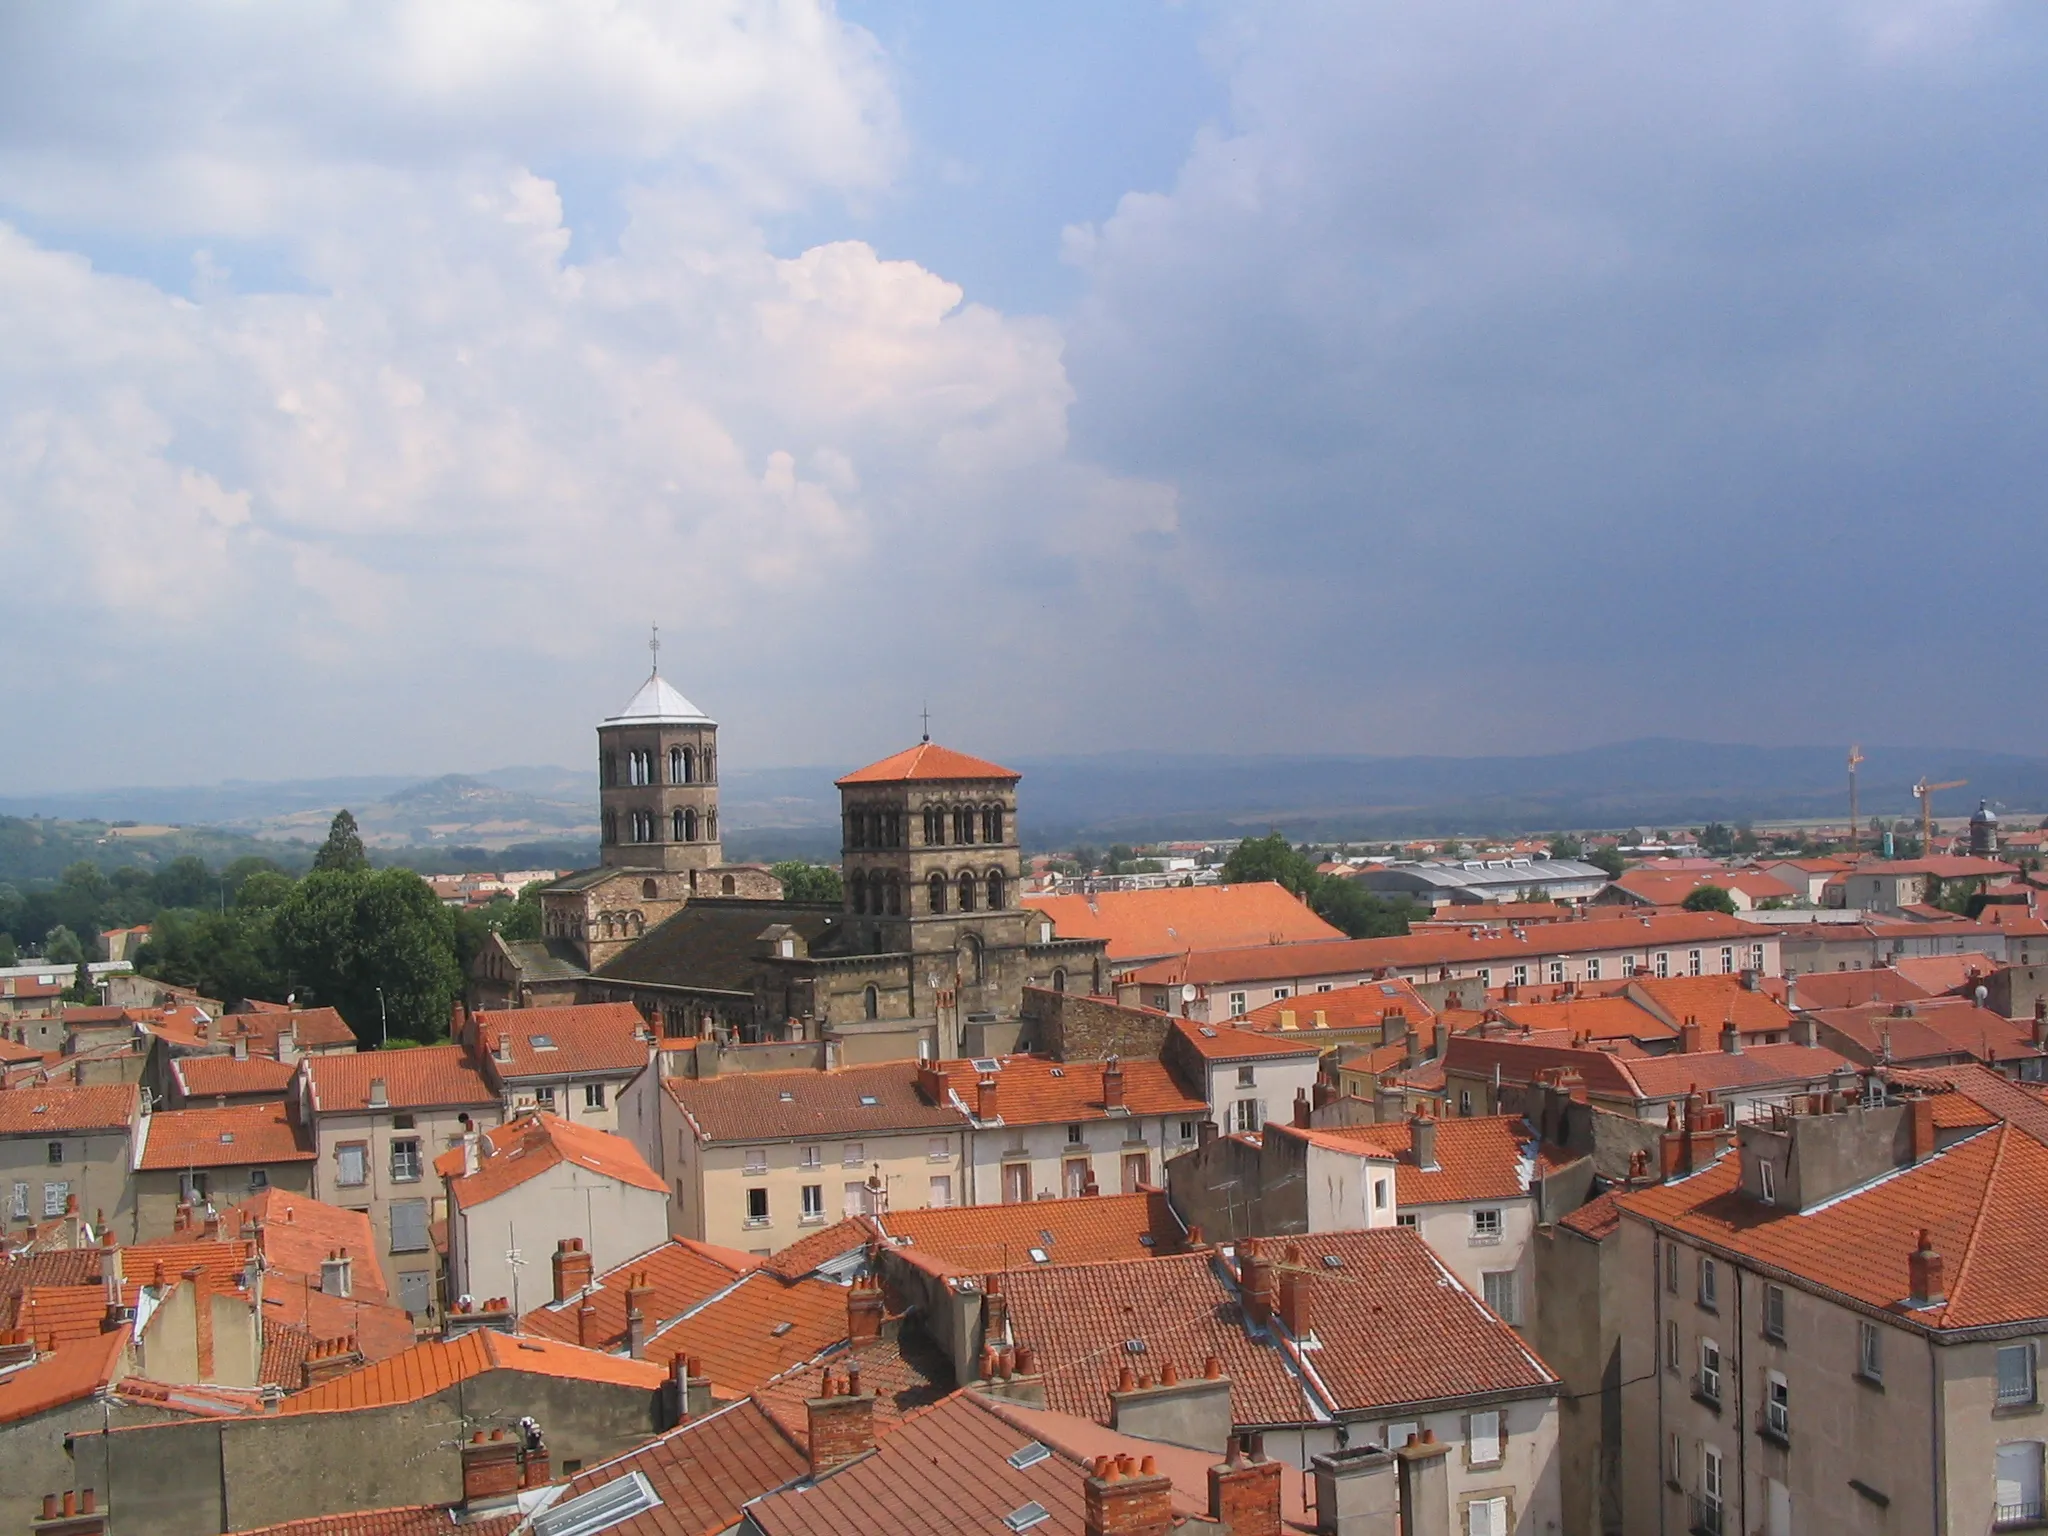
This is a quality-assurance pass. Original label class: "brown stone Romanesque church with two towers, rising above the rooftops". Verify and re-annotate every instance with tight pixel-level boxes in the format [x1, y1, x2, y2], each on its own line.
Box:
[469, 662, 1108, 1065]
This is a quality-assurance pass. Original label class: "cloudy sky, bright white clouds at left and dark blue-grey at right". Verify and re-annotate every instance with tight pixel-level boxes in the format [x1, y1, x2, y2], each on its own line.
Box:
[0, 0, 2048, 793]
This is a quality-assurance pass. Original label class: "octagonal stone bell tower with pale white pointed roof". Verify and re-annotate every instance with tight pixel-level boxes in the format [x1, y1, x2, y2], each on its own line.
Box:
[598, 637, 725, 885]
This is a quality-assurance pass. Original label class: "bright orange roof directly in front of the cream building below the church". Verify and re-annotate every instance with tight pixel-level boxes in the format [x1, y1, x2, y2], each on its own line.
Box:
[868, 1192, 1184, 1274]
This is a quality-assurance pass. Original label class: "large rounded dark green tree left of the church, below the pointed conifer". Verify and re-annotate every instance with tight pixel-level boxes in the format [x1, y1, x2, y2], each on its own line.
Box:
[272, 868, 463, 1040]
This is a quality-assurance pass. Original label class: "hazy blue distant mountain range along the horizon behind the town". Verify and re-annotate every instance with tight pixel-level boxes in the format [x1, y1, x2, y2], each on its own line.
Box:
[0, 737, 2048, 858]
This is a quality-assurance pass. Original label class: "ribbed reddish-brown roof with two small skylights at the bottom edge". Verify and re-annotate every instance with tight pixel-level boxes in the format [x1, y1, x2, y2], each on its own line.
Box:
[748, 1393, 1083, 1536]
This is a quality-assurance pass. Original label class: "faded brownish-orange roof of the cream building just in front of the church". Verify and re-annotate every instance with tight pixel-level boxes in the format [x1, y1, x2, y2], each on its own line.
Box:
[662, 1061, 973, 1141]
